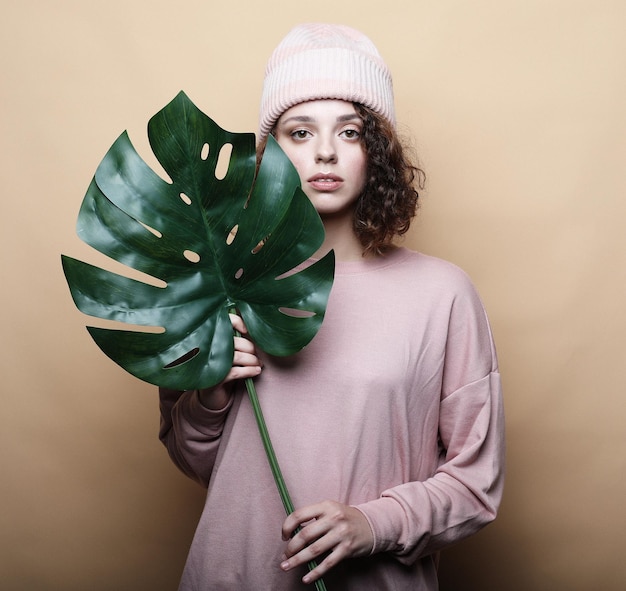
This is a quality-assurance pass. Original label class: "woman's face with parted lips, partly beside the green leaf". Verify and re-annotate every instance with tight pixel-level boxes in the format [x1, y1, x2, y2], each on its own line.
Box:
[275, 99, 367, 217]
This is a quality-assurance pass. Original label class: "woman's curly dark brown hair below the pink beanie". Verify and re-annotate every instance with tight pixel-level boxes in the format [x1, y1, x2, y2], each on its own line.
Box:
[257, 103, 426, 256]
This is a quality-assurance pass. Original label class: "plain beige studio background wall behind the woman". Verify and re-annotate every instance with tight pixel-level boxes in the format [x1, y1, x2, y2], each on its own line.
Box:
[0, 0, 626, 591]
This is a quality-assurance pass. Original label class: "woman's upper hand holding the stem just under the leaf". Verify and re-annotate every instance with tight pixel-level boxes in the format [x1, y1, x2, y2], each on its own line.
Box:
[198, 314, 263, 410]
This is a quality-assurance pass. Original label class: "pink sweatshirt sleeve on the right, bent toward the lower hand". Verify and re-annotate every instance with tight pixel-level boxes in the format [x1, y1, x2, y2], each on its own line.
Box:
[357, 272, 505, 564]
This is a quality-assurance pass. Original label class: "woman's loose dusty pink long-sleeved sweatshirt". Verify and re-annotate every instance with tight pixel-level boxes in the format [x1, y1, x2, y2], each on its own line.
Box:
[160, 248, 504, 591]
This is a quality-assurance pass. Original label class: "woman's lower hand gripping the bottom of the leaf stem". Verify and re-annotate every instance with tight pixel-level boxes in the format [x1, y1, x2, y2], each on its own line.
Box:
[280, 501, 374, 583]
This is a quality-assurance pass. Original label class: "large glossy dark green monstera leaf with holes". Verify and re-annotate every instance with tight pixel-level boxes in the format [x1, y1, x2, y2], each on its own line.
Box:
[62, 92, 334, 390]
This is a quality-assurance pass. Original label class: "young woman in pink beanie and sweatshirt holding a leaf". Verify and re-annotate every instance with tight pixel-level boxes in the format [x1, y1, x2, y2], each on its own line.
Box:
[160, 24, 504, 591]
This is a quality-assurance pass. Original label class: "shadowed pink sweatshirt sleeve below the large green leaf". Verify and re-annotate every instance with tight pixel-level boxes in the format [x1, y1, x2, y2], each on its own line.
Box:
[159, 388, 232, 487]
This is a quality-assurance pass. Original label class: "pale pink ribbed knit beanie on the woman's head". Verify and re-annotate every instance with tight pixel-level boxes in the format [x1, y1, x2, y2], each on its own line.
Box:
[259, 23, 395, 139]
